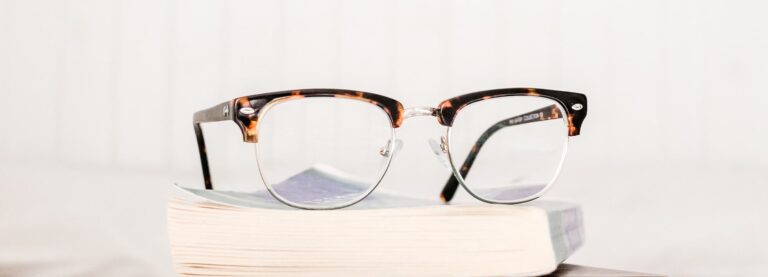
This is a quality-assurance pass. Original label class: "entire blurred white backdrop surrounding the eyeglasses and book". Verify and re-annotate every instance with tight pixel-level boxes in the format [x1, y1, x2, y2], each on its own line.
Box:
[0, 0, 768, 276]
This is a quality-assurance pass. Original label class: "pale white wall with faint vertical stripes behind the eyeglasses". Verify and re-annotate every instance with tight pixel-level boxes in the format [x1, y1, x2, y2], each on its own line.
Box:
[0, 0, 768, 171]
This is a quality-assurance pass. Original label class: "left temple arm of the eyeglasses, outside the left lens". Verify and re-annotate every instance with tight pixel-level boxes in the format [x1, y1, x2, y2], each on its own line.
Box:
[192, 101, 232, 189]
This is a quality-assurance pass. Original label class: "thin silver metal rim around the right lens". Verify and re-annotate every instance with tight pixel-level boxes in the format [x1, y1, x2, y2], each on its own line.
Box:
[445, 96, 569, 204]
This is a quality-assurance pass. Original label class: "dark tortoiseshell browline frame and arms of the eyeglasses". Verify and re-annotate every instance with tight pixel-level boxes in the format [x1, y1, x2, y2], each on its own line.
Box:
[193, 88, 587, 206]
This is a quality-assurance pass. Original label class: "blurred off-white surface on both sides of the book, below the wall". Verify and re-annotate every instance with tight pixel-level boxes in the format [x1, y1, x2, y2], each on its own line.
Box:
[0, 163, 768, 276]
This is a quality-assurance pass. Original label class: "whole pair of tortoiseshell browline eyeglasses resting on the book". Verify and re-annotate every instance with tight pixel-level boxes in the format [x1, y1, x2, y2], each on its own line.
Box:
[194, 88, 587, 209]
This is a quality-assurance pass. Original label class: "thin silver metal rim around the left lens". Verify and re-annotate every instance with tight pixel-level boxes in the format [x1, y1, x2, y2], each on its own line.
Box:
[254, 97, 397, 210]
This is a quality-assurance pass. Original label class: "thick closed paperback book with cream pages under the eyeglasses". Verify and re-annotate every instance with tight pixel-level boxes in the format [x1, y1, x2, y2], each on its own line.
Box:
[168, 165, 584, 276]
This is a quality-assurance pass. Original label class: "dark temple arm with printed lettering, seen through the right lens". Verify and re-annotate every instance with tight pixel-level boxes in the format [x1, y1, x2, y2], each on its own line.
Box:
[440, 104, 563, 203]
